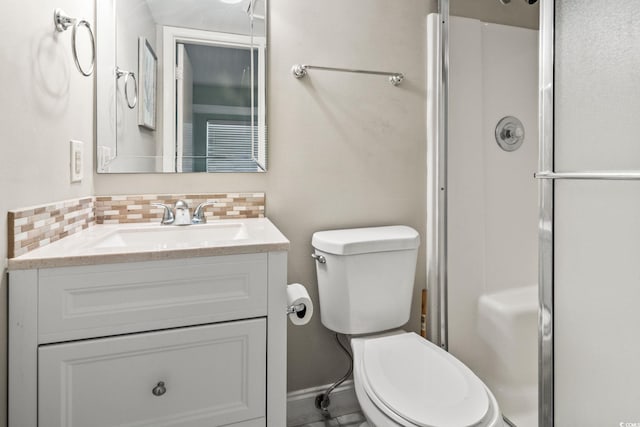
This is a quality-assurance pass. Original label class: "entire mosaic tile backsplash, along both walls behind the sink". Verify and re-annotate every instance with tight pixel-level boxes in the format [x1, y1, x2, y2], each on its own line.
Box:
[7, 193, 265, 258]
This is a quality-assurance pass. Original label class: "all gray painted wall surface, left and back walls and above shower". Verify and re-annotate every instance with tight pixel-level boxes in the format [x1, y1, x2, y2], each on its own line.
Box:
[0, 0, 533, 425]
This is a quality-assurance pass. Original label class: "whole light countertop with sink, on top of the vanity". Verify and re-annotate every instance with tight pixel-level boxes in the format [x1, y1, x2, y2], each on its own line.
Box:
[9, 218, 289, 271]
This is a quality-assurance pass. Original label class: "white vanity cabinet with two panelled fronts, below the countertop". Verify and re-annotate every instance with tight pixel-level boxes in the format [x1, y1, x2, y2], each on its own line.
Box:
[9, 251, 286, 427]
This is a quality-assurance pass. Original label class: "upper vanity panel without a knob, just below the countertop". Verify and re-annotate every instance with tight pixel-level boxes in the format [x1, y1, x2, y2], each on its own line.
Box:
[38, 253, 267, 343]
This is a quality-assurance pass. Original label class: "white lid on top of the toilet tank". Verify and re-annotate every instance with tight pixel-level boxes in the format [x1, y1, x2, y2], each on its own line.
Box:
[311, 225, 420, 255]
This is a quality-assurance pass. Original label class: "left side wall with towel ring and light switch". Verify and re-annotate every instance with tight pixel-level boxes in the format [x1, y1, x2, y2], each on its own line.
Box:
[0, 0, 95, 425]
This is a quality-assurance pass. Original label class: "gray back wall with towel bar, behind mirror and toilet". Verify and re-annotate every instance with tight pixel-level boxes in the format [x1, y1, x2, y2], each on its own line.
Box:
[95, 0, 430, 390]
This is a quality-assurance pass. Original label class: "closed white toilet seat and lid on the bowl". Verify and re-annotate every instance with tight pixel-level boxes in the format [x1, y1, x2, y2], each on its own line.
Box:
[352, 332, 496, 427]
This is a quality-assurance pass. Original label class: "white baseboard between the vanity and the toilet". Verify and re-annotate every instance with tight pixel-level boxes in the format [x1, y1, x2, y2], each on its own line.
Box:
[287, 380, 360, 426]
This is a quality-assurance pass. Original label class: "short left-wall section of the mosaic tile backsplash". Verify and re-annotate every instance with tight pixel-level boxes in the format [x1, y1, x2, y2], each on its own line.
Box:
[7, 197, 95, 258]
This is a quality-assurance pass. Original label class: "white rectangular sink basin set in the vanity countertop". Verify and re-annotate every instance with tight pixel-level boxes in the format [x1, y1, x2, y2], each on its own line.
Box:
[90, 223, 249, 251]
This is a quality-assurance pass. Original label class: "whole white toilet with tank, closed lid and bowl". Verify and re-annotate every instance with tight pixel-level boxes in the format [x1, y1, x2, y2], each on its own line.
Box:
[312, 226, 504, 427]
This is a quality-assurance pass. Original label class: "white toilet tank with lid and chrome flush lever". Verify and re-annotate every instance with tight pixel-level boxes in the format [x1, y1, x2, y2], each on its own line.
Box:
[311, 226, 420, 335]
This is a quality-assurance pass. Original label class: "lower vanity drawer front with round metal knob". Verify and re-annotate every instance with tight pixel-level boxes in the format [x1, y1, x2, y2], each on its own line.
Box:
[38, 319, 266, 427]
